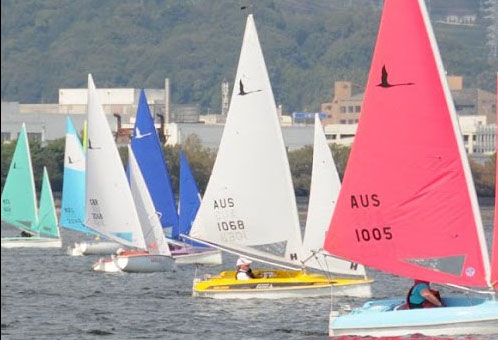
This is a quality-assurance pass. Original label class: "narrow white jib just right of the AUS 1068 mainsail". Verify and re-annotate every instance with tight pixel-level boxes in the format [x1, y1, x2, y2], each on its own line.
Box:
[303, 114, 365, 275]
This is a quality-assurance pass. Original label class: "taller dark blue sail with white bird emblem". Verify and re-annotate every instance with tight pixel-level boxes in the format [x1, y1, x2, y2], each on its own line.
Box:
[131, 90, 178, 236]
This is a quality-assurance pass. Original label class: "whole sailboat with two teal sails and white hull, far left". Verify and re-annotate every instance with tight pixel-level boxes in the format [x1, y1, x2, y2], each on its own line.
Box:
[1, 123, 62, 248]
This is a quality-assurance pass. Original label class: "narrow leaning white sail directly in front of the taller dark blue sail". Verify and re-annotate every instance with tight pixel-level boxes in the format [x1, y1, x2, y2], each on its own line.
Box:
[128, 145, 171, 256]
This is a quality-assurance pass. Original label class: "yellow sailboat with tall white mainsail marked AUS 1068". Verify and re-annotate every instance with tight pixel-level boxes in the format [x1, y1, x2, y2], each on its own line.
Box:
[185, 14, 368, 299]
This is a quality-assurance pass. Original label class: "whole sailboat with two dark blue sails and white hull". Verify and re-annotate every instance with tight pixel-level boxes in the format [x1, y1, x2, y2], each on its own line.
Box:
[131, 90, 222, 265]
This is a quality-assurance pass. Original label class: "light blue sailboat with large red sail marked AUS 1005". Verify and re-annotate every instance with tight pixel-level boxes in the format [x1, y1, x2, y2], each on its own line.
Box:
[324, 0, 498, 336]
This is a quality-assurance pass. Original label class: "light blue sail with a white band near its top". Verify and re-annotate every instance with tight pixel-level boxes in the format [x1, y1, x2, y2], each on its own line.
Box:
[60, 117, 97, 235]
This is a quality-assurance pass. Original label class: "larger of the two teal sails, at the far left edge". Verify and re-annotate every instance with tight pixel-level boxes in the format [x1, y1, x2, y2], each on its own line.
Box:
[1, 123, 38, 233]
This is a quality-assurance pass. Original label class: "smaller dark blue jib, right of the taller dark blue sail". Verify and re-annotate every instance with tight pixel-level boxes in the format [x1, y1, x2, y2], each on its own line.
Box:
[179, 151, 201, 238]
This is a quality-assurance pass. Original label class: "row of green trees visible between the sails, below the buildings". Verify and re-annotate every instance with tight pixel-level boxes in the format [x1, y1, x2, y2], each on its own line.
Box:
[1, 135, 496, 197]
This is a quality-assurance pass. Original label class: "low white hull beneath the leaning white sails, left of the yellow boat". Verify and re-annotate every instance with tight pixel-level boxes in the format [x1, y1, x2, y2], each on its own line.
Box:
[92, 254, 175, 273]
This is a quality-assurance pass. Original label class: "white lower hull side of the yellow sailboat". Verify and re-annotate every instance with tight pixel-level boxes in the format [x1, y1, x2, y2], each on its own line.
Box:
[192, 281, 372, 300]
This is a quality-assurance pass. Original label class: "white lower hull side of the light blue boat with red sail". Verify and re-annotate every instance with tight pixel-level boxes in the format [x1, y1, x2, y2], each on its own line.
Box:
[329, 312, 498, 337]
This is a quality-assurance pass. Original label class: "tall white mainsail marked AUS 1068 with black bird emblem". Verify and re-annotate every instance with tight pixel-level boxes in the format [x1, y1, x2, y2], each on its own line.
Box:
[190, 15, 302, 264]
